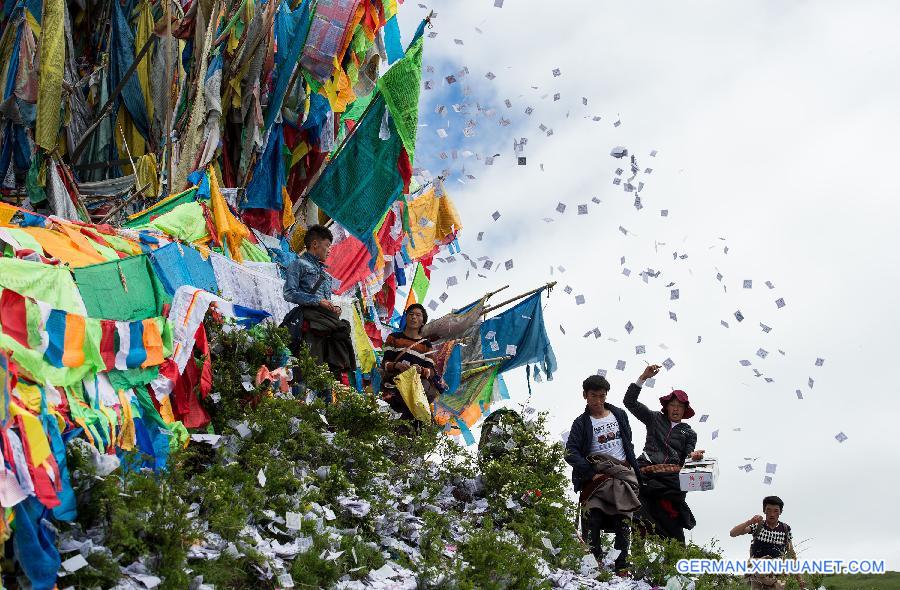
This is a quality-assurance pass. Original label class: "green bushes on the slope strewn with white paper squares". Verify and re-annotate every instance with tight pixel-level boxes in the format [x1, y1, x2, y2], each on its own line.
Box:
[51, 322, 752, 590]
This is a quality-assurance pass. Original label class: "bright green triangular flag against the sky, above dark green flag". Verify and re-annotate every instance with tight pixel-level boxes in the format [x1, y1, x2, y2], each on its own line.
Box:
[378, 37, 423, 163]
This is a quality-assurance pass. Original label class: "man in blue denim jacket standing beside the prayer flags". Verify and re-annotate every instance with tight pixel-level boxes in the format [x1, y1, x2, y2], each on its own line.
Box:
[282, 225, 356, 383]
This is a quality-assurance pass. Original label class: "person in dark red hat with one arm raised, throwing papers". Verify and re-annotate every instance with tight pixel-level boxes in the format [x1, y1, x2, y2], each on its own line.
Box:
[625, 365, 703, 543]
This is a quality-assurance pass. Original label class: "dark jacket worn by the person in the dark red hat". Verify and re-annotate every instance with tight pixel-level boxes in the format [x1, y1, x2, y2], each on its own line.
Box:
[625, 383, 697, 465]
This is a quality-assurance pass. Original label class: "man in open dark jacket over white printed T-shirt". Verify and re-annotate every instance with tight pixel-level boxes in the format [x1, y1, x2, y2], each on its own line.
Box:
[566, 375, 641, 575]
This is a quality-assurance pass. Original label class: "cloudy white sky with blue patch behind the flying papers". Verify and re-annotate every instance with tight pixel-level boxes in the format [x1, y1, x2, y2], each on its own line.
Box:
[400, 0, 900, 570]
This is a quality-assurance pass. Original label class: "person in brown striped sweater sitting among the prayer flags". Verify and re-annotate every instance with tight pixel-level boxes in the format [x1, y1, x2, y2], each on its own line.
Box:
[381, 303, 443, 421]
